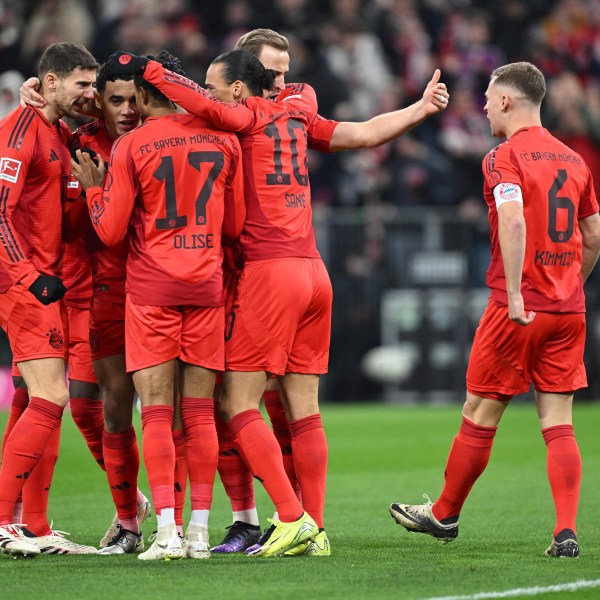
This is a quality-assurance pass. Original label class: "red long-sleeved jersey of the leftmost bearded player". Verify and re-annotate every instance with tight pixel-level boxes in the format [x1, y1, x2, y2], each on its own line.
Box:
[0, 106, 71, 292]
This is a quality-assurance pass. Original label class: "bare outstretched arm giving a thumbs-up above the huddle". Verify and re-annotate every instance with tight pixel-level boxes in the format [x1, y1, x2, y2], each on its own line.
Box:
[324, 69, 450, 152]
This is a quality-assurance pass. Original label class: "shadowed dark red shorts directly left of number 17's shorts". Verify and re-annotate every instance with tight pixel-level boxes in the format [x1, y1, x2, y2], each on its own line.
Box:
[90, 294, 125, 360]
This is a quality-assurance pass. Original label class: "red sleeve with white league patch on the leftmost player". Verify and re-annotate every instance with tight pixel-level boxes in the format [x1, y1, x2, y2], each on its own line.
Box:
[0, 109, 39, 286]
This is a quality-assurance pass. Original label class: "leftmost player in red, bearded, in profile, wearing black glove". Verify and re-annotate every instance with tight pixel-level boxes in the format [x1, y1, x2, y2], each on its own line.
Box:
[0, 42, 98, 555]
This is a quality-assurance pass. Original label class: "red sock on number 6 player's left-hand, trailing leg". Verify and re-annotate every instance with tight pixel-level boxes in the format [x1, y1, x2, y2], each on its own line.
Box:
[433, 417, 498, 521]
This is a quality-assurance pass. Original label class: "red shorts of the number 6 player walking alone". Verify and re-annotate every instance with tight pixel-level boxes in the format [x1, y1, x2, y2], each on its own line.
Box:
[467, 298, 587, 400]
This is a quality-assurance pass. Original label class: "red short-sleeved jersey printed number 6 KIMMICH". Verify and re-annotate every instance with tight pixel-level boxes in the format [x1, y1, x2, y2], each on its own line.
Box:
[482, 127, 598, 313]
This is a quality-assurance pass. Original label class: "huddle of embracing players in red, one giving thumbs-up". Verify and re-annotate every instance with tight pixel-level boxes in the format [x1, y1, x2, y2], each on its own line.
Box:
[0, 29, 449, 560]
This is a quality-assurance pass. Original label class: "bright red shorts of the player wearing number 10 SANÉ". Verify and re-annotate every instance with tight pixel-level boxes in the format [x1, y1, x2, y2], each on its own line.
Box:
[225, 258, 333, 375]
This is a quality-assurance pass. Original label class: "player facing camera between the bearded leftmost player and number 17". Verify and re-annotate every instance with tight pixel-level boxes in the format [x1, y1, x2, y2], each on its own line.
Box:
[71, 67, 155, 554]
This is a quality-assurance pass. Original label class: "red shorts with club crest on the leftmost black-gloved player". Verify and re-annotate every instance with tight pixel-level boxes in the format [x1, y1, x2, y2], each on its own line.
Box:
[0, 283, 68, 363]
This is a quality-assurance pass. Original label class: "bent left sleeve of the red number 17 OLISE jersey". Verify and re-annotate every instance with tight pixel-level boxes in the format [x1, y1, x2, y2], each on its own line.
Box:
[87, 135, 137, 246]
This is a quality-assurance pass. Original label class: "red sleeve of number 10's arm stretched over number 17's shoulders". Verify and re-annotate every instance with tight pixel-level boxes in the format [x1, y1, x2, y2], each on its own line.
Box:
[144, 60, 256, 133]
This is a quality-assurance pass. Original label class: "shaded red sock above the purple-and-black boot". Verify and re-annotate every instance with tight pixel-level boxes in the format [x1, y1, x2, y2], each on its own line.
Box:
[214, 402, 256, 512]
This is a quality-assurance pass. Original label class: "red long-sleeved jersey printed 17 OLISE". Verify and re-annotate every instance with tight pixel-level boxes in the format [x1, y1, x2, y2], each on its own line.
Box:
[87, 114, 244, 306]
